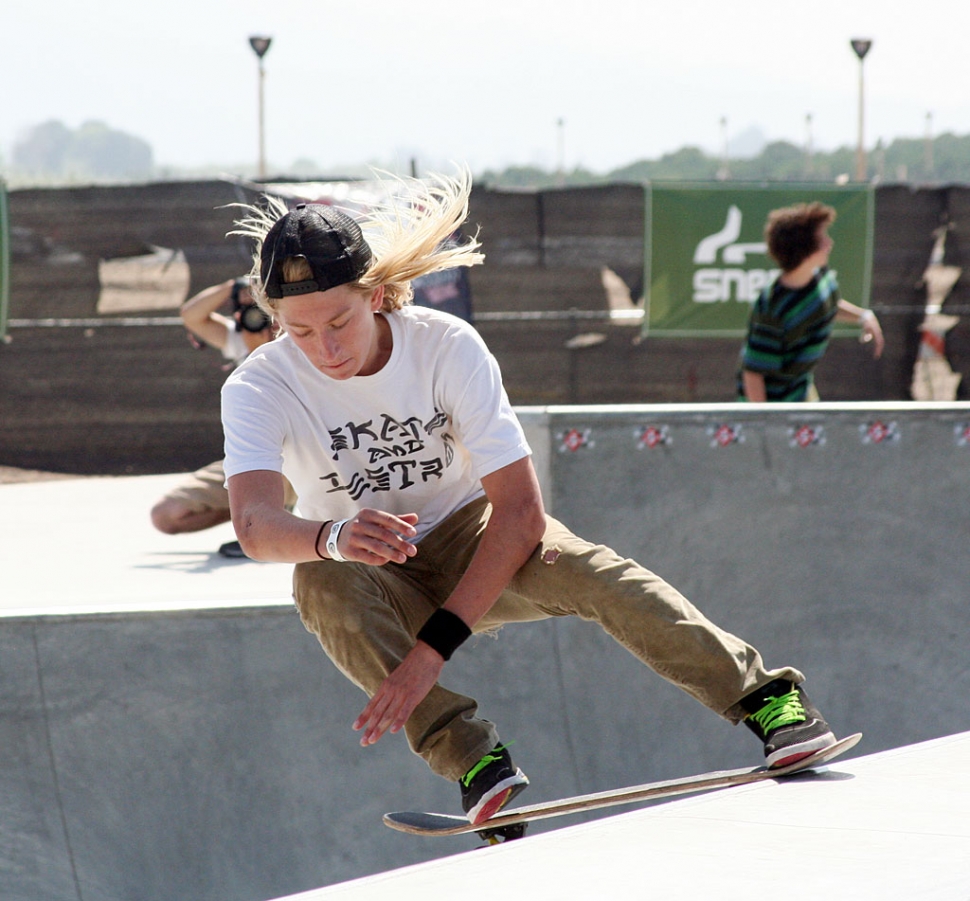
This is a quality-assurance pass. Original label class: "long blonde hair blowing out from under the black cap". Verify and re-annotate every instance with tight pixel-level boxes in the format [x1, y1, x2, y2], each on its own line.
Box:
[229, 168, 485, 316]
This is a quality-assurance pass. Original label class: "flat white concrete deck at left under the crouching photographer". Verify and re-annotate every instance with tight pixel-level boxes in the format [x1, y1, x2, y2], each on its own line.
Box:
[0, 474, 292, 616]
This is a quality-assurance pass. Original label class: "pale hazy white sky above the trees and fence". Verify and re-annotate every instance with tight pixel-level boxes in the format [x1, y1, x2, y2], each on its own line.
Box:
[0, 0, 970, 175]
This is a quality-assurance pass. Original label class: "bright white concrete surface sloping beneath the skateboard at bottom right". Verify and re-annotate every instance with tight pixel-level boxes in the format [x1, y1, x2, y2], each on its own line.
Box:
[268, 733, 970, 901]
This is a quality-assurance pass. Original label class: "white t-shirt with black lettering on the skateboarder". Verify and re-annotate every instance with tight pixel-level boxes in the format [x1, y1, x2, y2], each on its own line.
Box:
[222, 306, 531, 540]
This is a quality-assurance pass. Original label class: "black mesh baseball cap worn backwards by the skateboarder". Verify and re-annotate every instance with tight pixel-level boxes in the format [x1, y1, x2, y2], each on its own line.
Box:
[259, 203, 373, 298]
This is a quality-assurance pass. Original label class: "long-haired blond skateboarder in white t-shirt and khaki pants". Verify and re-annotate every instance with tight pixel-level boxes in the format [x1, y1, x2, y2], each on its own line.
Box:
[223, 174, 835, 823]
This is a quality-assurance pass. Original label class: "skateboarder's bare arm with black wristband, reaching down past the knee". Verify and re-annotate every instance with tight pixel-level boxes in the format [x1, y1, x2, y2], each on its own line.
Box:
[354, 457, 546, 746]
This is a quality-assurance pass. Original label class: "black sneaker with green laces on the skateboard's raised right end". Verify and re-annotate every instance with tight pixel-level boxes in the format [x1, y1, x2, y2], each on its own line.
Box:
[741, 679, 835, 769]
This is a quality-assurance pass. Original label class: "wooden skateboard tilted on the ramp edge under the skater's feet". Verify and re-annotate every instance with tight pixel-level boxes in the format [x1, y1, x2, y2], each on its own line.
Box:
[384, 732, 862, 844]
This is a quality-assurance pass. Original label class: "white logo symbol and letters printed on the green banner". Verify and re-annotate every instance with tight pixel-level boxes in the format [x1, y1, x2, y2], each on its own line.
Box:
[693, 204, 778, 303]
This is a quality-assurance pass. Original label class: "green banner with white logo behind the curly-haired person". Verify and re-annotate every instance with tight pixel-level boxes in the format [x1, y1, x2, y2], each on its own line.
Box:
[643, 183, 875, 337]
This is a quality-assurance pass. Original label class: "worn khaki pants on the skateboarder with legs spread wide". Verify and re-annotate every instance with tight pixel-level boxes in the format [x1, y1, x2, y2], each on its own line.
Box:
[293, 499, 804, 781]
